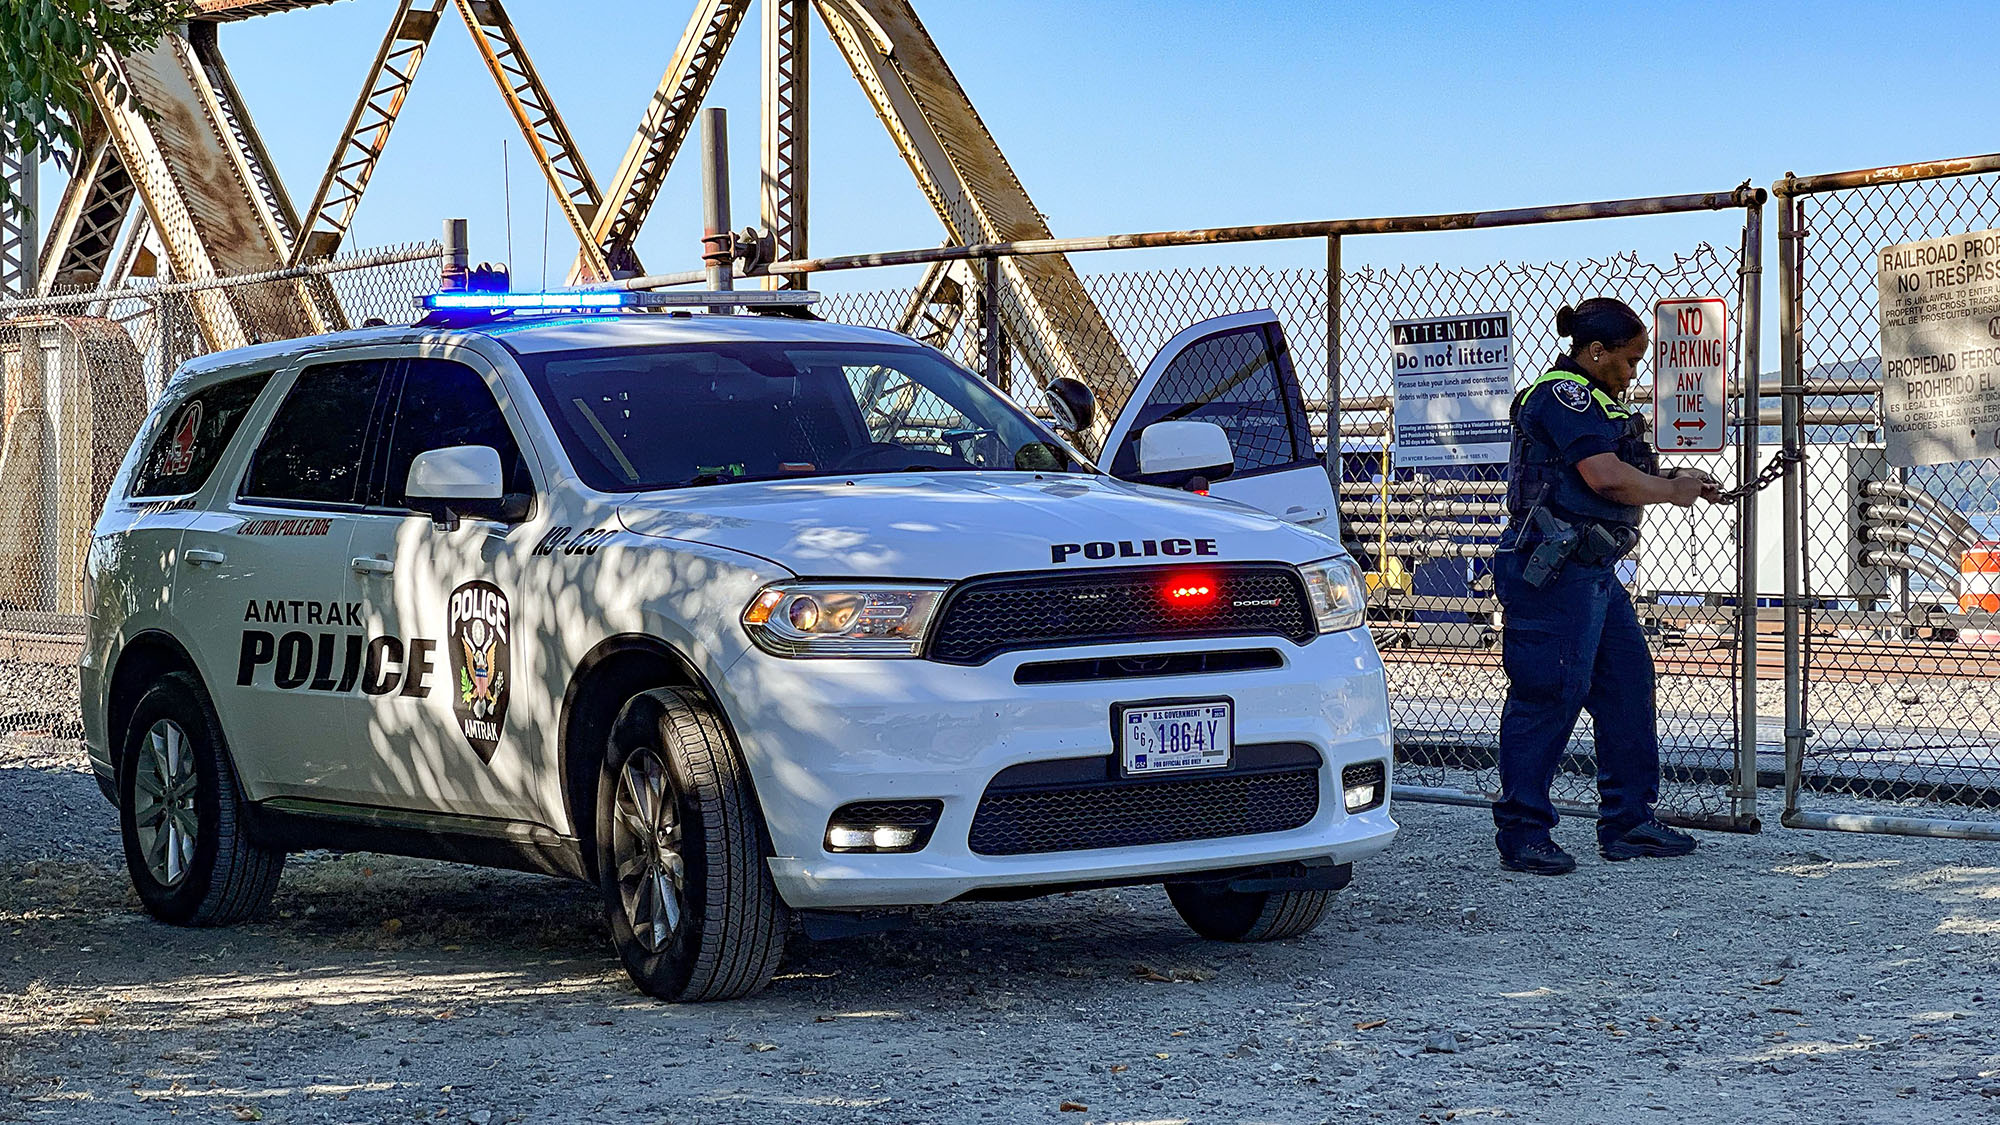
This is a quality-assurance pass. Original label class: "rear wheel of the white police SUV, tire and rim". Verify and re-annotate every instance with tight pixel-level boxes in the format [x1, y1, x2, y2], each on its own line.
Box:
[118, 673, 284, 927]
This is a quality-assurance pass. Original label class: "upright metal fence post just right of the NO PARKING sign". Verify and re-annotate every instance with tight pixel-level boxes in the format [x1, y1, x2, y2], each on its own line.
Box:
[1730, 192, 1764, 825]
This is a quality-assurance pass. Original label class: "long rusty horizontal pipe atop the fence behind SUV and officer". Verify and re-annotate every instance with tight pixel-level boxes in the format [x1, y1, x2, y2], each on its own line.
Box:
[762, 186, 1764, 274]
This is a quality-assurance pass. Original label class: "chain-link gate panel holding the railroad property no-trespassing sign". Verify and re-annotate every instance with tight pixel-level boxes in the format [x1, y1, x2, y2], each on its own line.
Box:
[1792, 158, 2000, 839]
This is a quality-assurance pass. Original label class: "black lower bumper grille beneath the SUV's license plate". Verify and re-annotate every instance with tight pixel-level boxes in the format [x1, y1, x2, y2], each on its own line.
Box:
[968, 745, 1320, 855]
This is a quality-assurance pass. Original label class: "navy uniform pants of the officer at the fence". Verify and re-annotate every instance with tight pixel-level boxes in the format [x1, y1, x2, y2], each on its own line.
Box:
[1494, 550, 1660, 851]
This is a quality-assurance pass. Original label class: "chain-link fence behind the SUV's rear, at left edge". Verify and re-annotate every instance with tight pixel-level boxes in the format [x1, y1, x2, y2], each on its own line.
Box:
[0, 244, 440, 749]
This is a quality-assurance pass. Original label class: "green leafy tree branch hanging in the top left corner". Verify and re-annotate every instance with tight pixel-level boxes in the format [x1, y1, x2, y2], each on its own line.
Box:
[0, 0, 194, 208]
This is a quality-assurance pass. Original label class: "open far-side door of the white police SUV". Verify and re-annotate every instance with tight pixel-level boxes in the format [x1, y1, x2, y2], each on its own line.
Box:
[1104, 308, 1338, 534]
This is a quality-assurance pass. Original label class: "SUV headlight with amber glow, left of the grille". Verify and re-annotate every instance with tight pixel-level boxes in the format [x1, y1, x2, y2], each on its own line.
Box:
[744, 583, 944, 657]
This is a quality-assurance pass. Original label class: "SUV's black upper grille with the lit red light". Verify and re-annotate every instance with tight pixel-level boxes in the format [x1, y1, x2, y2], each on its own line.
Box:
[928, 563, 1316, 665]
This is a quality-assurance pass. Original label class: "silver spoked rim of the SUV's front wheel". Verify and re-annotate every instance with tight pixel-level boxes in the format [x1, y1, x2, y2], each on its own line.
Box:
[612, 751, 688, 953]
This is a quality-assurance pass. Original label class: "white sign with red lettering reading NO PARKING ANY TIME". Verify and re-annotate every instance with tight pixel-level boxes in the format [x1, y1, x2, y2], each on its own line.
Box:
[1652, 296, 1730, 452]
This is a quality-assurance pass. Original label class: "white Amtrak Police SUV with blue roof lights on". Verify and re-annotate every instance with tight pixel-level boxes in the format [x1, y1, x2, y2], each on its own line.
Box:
[82, 292, 1396, 999]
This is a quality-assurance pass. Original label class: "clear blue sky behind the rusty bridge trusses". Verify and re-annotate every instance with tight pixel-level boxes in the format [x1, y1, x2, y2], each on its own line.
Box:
[44, 0, 2000, 284]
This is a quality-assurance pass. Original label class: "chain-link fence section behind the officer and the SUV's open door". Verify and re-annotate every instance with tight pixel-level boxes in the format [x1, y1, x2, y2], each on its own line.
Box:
[820, 192, 1780, 829]
